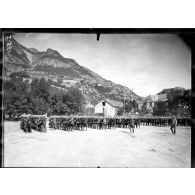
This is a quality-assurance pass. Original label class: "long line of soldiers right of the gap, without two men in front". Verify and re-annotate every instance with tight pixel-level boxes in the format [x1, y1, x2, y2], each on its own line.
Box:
[50, 116, 190, 131]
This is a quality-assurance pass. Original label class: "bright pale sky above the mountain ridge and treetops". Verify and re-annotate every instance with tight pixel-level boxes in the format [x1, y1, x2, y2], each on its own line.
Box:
[14, 33, 191, 96]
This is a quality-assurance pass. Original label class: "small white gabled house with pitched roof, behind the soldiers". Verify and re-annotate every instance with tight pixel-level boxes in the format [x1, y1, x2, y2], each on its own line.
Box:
[95, 100, 123, 117]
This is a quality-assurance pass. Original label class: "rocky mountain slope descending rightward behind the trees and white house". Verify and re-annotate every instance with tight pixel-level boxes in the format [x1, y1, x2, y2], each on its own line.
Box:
[4, 38, 141, 103]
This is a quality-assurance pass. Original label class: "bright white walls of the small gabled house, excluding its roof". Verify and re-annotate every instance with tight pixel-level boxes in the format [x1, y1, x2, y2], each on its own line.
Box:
[95, 101, 117, 117]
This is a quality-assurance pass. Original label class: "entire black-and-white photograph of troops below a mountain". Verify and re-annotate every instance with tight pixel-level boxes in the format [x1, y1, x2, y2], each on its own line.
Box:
[2, 30, 192, 168]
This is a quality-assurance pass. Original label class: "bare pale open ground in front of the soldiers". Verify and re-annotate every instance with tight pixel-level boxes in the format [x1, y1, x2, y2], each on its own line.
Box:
[4, 121, 191, 167]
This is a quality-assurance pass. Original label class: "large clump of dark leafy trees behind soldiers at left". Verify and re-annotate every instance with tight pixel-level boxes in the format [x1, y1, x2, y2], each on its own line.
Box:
[3, 78, 85, 118]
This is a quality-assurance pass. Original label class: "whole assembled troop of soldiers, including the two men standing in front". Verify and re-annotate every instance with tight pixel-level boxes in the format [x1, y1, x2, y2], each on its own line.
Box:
[21, 115, 191, 134]
